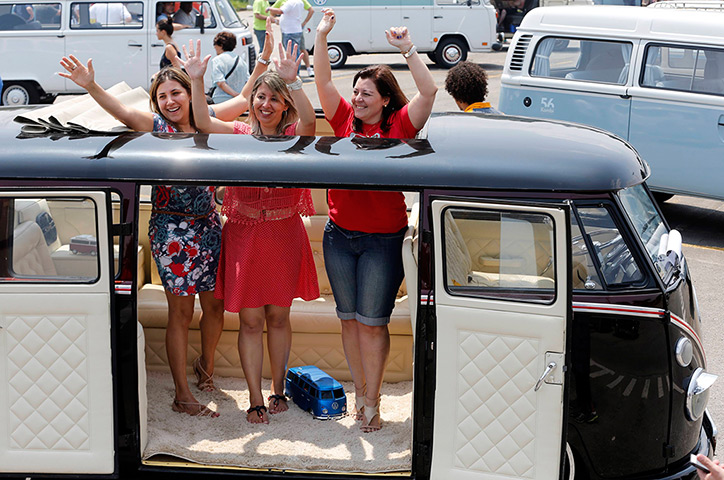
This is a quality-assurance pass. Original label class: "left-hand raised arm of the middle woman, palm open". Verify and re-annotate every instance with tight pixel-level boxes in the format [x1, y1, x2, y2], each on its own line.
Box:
[182, 40, 234, 133]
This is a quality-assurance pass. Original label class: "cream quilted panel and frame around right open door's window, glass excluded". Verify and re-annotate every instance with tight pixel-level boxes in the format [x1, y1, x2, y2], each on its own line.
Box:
[431, 201, 570, 480]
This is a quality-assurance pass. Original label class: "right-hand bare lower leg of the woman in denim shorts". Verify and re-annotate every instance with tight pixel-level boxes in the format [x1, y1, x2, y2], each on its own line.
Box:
[358, 323, 390, 432]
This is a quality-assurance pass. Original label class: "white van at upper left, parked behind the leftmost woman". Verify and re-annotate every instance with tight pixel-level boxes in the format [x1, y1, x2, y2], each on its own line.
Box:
[0, 0, 256, 105]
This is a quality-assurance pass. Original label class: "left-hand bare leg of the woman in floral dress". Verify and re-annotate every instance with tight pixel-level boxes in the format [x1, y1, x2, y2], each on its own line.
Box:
[164, 290, 216, 415]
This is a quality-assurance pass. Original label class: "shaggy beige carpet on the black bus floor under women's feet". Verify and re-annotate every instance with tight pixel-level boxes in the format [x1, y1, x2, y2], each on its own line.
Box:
[143, 372, 412, 473]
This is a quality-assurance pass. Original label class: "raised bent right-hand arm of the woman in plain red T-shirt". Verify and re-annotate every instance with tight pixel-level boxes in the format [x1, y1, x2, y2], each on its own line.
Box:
[385, 27, 437, 129]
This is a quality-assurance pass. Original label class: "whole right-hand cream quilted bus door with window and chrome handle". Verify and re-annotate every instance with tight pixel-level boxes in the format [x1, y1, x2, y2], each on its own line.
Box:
[431, 200, 571, 480]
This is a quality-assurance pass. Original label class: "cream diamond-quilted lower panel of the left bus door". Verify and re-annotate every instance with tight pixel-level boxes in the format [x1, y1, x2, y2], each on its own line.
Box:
[0, 293, 114, 473]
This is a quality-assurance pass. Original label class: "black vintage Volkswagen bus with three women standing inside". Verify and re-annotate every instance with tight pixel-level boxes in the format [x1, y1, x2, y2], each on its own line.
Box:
[0, 113, 717, 480]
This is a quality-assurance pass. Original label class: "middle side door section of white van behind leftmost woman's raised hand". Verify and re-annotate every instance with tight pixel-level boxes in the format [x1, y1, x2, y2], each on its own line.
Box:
[65, 1, 148, 91]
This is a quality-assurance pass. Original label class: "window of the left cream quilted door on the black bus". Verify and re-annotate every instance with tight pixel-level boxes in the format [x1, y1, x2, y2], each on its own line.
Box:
[0, 197, 100, 283]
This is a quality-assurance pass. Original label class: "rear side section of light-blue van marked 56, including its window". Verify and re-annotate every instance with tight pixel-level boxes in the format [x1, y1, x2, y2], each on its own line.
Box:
[499, 36, 634, 139]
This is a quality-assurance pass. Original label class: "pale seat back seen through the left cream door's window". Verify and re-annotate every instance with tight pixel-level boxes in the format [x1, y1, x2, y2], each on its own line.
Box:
[13, 220, 56, 276]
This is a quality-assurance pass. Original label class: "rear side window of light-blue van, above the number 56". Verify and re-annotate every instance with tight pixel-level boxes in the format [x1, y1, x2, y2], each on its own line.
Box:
[530, 37, 633, 85]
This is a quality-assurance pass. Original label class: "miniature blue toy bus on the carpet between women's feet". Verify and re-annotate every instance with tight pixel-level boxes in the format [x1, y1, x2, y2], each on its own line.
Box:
[284, 365, 347, 420]
